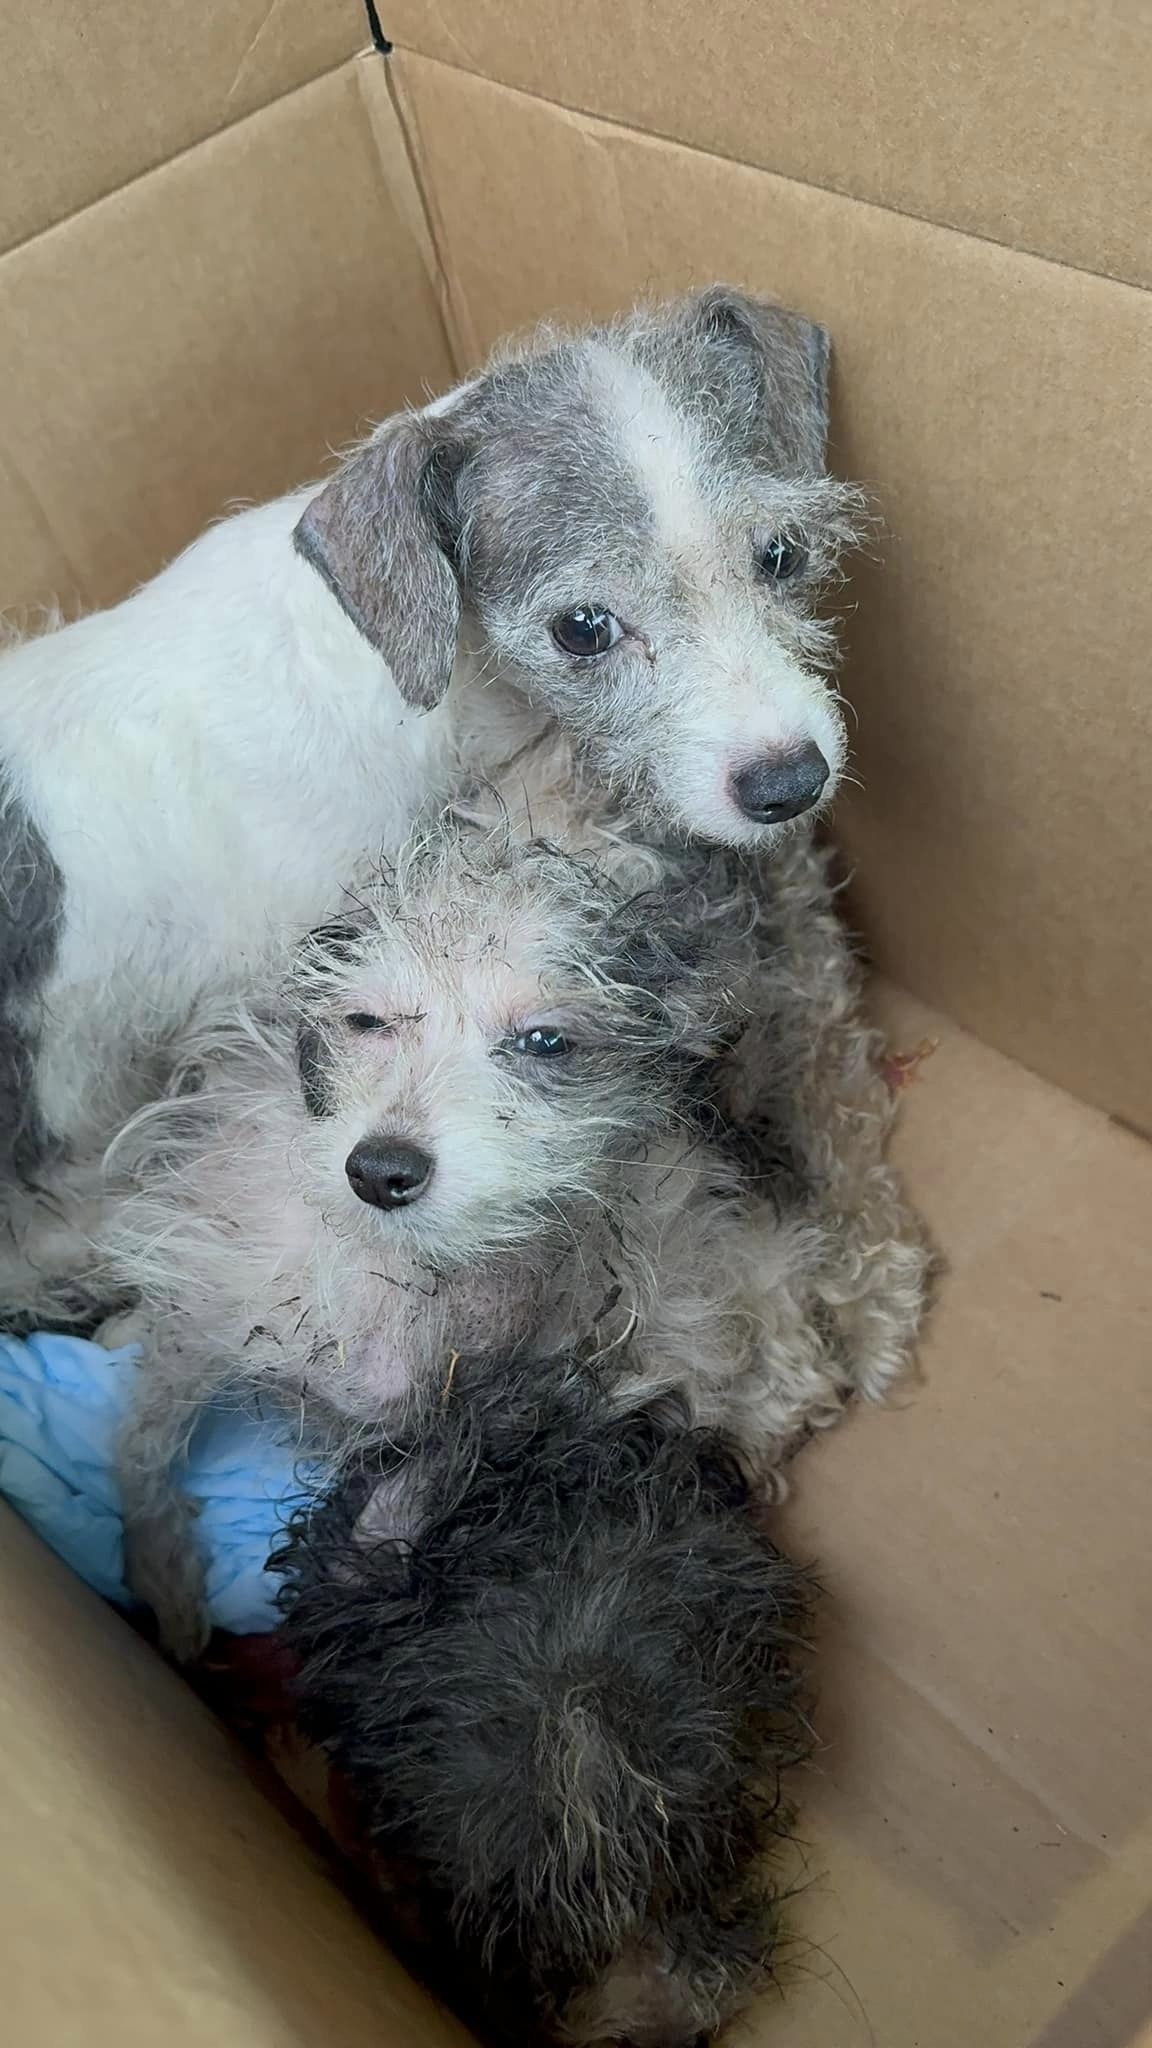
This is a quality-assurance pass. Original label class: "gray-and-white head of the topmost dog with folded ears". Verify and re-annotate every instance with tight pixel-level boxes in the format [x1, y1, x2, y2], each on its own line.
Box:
[297, 287, 857, 846]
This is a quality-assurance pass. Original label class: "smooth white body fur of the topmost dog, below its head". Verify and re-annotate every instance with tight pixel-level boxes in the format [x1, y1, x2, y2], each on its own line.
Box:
[0, 492, 453, 1145]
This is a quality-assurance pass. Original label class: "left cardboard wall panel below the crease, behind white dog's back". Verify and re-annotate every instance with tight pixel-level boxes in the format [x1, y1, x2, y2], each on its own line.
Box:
[0, 63, 451, 610]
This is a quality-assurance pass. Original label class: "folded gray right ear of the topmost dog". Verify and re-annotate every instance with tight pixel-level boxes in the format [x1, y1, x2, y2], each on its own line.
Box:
[693, 285, 832, 471]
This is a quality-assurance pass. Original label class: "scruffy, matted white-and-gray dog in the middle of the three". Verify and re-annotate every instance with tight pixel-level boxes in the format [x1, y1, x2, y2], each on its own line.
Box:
[105, 745, 922, 1655]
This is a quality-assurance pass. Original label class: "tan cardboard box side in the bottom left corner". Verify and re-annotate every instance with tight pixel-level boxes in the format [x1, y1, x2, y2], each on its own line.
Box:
[0, 1509, 465, 2048]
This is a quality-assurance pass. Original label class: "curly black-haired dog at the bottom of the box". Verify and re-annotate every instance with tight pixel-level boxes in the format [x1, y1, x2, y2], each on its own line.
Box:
[271, 1358, 808, 2048]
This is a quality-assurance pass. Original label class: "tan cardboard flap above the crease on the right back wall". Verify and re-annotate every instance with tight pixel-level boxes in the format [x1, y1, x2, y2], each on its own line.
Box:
[385, 0, 1152, 283]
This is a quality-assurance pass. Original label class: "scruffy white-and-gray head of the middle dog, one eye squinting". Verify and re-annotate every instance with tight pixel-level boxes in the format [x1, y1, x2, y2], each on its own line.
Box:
[284, 827, 730, 1268]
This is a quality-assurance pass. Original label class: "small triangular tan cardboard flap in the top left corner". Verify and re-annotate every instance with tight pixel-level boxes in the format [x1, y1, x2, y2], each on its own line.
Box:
[0, 0, 367, 250]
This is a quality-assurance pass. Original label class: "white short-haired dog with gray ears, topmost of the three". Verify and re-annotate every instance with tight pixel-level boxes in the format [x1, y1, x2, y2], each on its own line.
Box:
[0, 287, 857, 1315]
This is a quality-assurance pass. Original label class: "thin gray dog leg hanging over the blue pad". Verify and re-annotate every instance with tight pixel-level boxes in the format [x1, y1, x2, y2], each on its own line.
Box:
[98, 1315, 211, 1663]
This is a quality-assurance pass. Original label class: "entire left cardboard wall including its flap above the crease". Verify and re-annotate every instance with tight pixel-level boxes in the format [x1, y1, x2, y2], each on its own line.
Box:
[0, 0, 451, 616]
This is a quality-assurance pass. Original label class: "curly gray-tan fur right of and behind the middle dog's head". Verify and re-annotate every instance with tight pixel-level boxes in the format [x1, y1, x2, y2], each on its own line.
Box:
[444, 739, 929, 1444]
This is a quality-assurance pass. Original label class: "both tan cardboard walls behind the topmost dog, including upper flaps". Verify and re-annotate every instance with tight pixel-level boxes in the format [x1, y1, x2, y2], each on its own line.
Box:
[0, 0, 1152, 1128]
